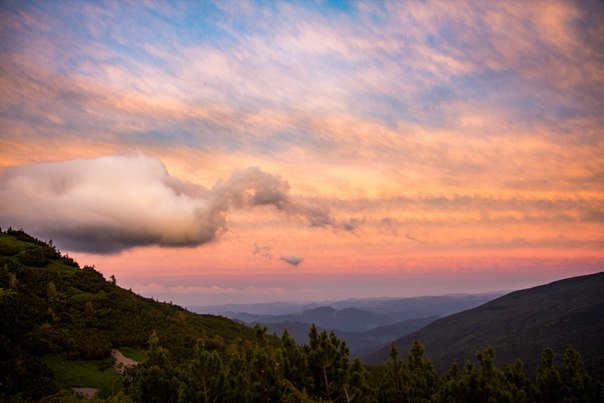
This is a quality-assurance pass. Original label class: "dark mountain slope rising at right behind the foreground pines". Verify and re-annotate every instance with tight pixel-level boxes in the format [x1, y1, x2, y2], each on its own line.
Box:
[364, 272, 604, 378]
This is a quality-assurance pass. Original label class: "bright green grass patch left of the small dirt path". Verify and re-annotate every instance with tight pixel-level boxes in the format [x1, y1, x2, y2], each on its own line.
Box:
[42, 354, 122, 399]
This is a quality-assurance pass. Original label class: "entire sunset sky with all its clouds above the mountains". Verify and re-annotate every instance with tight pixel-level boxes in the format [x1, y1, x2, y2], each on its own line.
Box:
[0, 0, 604, 306]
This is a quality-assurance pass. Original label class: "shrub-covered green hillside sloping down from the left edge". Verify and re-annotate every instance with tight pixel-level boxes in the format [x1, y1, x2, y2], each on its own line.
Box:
[0, 229, 254, 398]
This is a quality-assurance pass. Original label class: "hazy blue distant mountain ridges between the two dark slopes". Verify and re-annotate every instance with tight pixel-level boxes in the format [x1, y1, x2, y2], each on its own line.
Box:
[190, 293, 500, 357]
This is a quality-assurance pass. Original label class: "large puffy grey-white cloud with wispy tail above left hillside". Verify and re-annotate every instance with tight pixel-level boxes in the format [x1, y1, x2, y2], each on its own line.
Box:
[0, 154, 352, 252]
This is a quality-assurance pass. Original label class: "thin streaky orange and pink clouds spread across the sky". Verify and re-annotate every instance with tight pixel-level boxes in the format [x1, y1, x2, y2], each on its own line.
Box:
[0, 1, 604, 304]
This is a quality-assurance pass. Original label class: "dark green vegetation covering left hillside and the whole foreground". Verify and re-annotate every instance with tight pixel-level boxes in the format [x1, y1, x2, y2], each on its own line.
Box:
[0, 230, 604, 402]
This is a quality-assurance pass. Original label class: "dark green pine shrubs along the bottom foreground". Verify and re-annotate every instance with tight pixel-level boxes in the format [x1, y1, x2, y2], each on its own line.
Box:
[119, 326, 604, 402]
